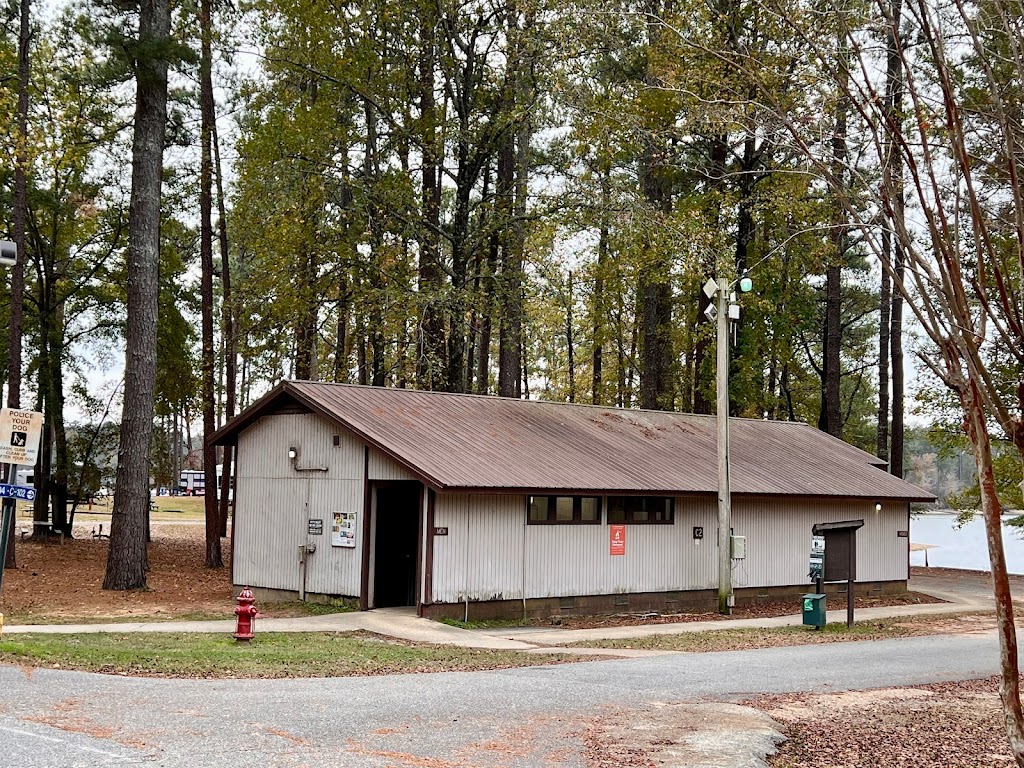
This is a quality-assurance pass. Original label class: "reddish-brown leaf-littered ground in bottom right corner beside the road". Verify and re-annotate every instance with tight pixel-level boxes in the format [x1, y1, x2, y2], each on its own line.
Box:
[751, 678, 1014, 768]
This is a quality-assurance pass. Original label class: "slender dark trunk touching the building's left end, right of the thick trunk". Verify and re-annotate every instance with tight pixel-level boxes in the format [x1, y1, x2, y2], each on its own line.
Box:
[199, 0, 224, 568]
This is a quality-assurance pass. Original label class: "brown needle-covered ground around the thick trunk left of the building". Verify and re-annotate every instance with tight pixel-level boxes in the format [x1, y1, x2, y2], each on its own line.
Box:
[0, 522, 234, 624]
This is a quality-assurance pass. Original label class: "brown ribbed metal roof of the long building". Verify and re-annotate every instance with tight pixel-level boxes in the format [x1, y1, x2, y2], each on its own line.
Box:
[211, 381, 934, 501]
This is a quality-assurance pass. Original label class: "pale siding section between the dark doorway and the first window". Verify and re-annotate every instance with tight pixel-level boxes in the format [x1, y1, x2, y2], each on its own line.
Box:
[432, 494, 525, 603]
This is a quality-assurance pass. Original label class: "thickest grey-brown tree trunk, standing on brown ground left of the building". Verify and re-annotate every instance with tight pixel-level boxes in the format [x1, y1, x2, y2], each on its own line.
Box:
[103, 0, 171, 590]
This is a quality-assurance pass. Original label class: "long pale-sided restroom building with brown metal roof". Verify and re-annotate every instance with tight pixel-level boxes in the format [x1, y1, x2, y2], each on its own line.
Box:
[211, 382, 932, 617]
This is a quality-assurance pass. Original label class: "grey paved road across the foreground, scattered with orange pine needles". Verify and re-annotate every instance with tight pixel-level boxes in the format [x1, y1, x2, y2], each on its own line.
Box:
[0, 633, 997, 768]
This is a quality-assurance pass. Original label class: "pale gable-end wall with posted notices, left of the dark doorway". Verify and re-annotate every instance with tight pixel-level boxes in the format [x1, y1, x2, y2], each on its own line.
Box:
[232, 414, 364, 596]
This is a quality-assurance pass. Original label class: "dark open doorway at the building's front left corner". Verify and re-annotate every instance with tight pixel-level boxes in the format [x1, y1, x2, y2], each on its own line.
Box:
[374, 482, 422, 608]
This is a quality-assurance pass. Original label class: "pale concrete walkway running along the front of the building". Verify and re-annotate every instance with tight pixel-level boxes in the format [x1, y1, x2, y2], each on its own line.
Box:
[3, 569, 992, 656]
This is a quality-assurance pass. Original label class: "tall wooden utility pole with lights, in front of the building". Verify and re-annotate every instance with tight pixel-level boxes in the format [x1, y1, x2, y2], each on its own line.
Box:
[703, 272, 754, 615]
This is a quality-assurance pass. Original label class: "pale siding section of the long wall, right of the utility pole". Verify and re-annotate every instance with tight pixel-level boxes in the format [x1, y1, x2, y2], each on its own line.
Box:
[733, 498, 909, 587]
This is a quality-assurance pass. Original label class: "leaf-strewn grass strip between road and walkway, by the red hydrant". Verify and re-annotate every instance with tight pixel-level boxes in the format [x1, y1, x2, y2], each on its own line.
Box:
[0, 632, 565, 678]
